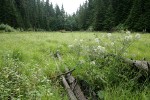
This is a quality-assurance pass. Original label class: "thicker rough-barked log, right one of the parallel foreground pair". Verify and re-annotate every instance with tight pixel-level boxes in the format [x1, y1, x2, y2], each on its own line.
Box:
[66, 68, 87, 100]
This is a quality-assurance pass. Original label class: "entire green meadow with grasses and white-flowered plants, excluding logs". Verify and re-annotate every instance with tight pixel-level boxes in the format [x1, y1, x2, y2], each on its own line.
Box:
[0, 32, 150, 100]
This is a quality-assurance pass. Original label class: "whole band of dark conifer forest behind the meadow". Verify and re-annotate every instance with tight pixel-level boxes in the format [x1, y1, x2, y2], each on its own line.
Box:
[0, 0, 150, 32]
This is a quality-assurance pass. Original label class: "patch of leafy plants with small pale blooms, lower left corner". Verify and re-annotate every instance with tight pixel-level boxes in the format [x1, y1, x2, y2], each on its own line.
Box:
[0, 53, 28, 100]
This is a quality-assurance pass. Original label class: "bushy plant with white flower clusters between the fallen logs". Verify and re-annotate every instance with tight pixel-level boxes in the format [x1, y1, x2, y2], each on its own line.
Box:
[68, 32, 145, 98]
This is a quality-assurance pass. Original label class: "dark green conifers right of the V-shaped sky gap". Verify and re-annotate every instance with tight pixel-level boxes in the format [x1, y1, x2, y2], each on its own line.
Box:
[76, 0, 150, 32]
